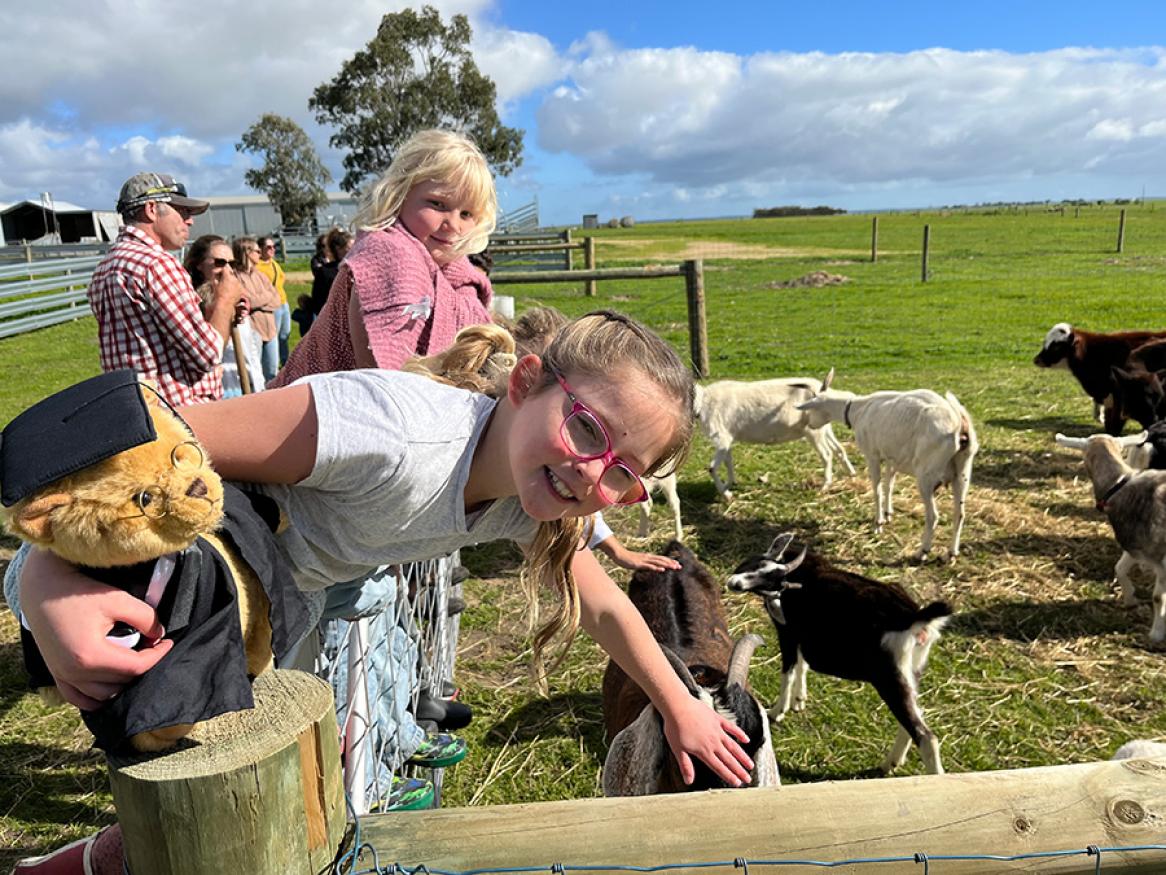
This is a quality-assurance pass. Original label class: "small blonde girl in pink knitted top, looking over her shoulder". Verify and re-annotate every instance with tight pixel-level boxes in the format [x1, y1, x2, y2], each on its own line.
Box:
[272, 131, 498, 386]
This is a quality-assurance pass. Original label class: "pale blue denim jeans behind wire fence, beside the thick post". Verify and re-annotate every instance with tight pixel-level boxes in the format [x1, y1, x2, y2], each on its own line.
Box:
[321, 568, 426, 796]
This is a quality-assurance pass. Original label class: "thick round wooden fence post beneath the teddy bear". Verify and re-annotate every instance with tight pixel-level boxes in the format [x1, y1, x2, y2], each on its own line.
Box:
[108, 670, 346, 875]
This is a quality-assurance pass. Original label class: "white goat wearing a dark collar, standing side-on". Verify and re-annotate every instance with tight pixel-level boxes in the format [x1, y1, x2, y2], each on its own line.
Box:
[799, 389, 979, 558]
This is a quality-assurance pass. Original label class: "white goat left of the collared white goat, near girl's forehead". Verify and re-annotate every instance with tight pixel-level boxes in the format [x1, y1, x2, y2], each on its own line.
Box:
[696, 370, 855, 501]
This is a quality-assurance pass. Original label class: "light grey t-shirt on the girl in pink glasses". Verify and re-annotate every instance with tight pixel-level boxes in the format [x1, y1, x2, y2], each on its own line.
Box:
[264, 370, 538, 590]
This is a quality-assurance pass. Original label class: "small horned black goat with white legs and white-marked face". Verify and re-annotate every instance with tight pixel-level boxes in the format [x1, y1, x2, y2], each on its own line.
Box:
[729, 533, 951, 775]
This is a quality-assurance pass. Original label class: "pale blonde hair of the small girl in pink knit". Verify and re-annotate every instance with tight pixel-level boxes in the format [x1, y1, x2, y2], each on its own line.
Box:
[352, 130, 498, 256]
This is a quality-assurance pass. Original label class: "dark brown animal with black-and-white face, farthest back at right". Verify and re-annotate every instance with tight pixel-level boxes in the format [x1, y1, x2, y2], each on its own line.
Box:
[1032, 322, 1166, 435]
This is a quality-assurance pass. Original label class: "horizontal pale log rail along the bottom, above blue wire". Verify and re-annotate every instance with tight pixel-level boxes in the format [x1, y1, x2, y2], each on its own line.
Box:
[360, 760, 1166, 875]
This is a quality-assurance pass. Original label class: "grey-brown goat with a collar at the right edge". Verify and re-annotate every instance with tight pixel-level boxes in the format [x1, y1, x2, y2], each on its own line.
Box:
[1056, 436, 1166, 644]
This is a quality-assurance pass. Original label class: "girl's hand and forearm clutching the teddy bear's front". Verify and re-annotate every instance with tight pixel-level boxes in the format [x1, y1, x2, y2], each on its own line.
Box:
[20, 550, 174, 711]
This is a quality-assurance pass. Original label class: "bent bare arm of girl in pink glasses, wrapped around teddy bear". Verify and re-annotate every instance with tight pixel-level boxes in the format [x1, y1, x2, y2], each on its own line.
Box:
[20, 385, 316, 708]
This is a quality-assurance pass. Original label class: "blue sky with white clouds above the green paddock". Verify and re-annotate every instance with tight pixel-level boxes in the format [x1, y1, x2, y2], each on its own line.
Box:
[0, 0, 1166, 224]
